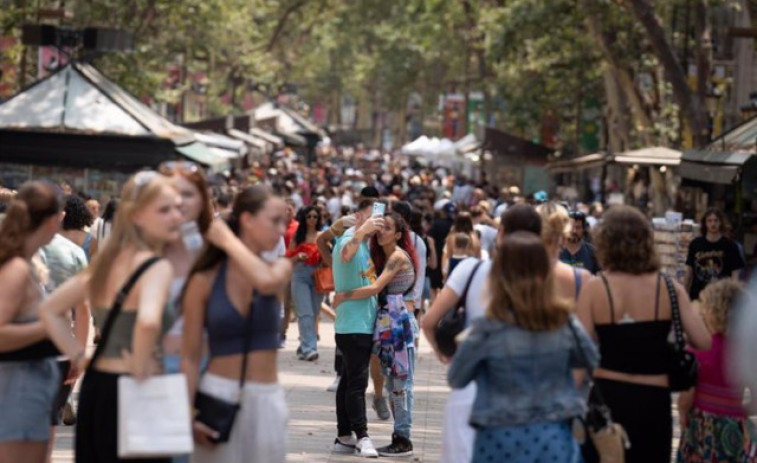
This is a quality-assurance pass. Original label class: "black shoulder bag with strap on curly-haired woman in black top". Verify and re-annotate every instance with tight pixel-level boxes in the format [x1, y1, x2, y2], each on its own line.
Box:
[662, 274, 699, 392]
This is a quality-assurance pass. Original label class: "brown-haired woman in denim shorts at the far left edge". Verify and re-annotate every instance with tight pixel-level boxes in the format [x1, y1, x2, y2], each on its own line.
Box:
[0, 182, 64, 463]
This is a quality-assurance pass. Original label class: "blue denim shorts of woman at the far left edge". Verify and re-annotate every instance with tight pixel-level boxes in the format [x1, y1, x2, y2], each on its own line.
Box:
[0, 358, 60, 442]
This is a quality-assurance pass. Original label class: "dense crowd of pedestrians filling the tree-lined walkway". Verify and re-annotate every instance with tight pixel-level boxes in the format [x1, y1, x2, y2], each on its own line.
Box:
[0, 146, 757, 463]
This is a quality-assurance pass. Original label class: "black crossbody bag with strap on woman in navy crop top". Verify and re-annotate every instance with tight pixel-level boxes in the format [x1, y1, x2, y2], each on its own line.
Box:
[194, 288, 252, 444]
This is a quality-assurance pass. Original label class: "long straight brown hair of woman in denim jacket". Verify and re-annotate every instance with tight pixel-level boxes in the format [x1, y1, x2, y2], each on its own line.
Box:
[486, 231, 571, 331]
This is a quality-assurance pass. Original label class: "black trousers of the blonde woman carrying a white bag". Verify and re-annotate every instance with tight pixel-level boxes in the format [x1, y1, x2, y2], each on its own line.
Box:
[75, 370, 171, 463]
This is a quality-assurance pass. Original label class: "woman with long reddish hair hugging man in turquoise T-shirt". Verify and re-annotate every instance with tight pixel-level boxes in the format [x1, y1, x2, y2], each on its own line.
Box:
[334, 212, 418, 457]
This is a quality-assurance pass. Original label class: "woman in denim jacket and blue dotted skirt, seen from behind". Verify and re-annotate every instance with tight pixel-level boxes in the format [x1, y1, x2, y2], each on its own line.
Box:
[447, 232, 598, 463]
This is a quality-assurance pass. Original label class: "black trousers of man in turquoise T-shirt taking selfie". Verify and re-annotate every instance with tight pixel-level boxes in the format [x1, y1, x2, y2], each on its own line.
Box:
[336, 334, 373, 439]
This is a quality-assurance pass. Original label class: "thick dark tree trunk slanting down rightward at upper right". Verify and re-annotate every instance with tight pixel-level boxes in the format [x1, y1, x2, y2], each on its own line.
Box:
[629, 0, 708, 146]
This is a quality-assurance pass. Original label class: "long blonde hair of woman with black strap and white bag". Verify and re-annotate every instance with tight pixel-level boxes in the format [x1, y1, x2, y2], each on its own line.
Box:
[88, 171, 173, 307]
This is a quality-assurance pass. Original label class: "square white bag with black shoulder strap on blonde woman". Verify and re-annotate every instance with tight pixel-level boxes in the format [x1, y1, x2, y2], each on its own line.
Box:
[87, 257, 194, 458]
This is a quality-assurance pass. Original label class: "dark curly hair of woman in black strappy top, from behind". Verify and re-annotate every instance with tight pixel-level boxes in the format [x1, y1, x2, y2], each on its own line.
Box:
[594, 205, 660, 275]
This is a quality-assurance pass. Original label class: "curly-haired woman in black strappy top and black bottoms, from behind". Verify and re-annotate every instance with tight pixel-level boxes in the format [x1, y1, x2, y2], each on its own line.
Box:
[577, 206, 711, 463]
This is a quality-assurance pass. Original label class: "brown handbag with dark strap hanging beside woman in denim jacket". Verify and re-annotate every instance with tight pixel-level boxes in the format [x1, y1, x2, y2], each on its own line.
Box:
[568, 320, 631, 463]
